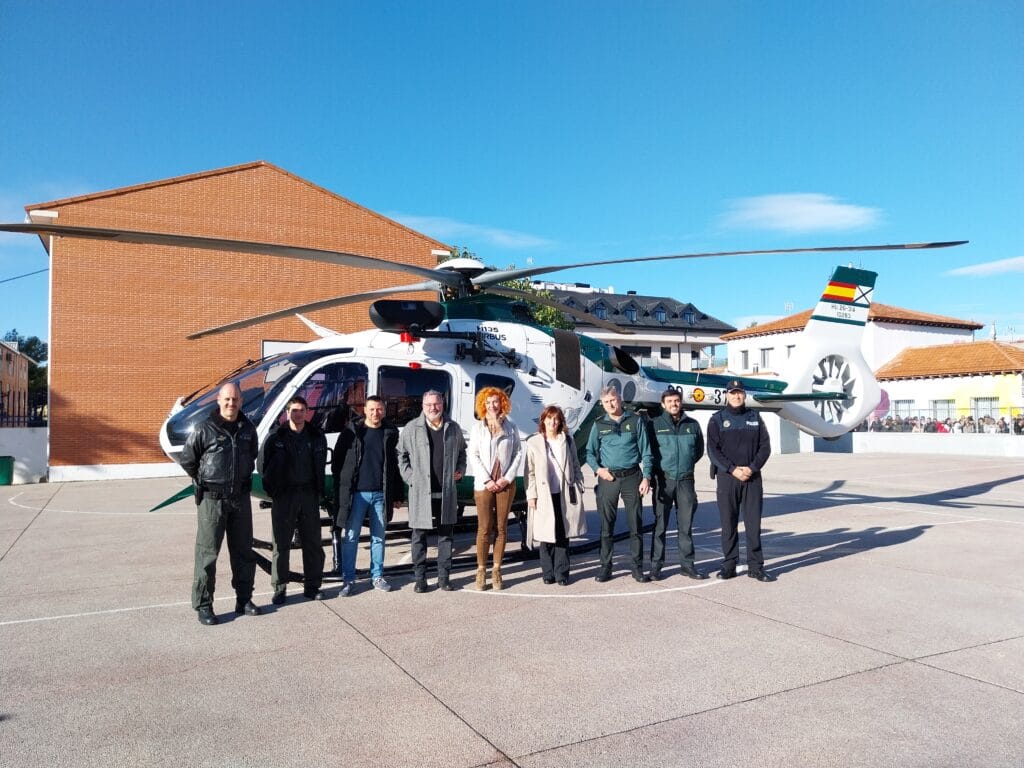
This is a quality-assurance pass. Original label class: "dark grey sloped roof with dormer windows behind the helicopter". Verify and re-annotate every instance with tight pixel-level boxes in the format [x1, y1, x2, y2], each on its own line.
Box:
[550, 289, 736, 334]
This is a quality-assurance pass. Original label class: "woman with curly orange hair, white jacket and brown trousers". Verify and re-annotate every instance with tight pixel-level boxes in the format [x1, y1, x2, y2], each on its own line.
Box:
[466, 387, 522, 590]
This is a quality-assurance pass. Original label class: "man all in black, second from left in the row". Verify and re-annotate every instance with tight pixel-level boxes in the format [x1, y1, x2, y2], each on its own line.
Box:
[263, 395, 327, 605]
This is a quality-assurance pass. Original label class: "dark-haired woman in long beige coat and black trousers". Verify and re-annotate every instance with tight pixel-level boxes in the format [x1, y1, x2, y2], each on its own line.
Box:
[526, 406, 587, 587]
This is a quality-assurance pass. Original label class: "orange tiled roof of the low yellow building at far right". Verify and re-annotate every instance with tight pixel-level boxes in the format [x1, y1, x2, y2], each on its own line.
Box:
[874, 341, 1024, 381]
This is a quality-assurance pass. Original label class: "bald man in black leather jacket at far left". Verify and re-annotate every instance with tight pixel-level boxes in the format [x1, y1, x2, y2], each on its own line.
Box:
[181, 384, 262, 625]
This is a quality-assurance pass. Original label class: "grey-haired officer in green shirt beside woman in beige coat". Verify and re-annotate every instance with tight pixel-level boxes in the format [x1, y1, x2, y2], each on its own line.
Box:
[587, 387, 652, 582]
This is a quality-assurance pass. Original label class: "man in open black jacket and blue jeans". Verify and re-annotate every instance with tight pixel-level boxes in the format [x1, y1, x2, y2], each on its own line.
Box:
[331, 395, 403, 597]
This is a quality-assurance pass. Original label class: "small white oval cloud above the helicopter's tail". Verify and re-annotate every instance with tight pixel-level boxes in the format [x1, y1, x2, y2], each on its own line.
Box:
[720, 193, 881, 232]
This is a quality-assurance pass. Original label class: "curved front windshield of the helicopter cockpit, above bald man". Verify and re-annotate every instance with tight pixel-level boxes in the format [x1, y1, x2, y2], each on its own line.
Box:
[167, 349, 338, 445]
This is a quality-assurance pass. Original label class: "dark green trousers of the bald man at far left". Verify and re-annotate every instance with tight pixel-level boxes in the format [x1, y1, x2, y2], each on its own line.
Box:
[193, 494, 256, 610]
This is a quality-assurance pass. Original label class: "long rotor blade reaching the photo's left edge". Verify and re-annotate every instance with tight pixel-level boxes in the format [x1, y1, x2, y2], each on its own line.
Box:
[0, 223, 464, 288]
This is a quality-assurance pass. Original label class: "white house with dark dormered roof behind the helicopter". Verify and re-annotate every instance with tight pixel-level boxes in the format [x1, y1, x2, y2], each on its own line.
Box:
[534, 282, 736, 371]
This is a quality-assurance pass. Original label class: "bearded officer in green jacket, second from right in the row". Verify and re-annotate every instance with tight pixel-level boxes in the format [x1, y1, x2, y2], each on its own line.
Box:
[650, 389, 708, 582]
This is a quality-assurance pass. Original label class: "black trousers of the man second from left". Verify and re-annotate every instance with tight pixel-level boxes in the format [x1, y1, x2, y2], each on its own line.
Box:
[270, 488, 324, 594]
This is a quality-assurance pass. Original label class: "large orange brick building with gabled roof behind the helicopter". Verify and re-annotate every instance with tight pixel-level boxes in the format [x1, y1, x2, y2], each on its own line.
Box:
[26, 162, 446, 480]
